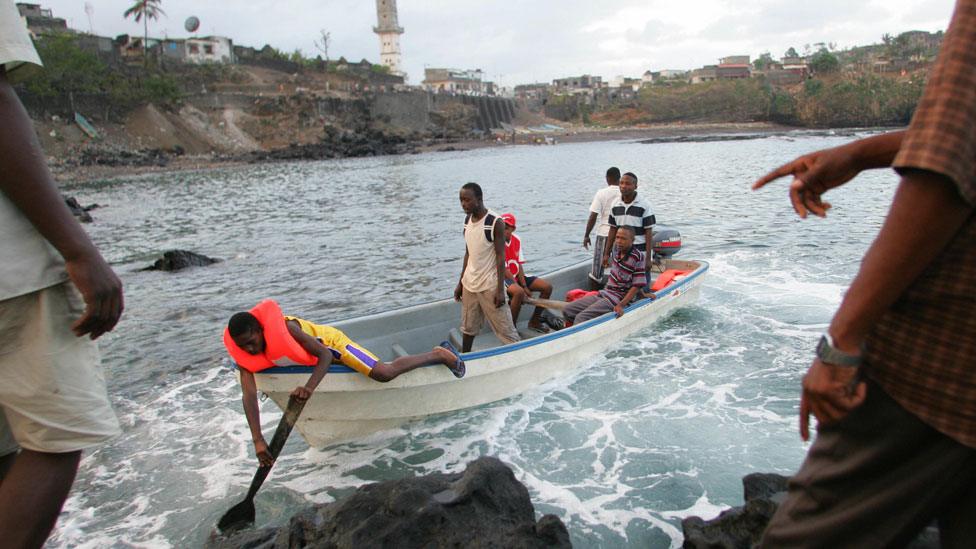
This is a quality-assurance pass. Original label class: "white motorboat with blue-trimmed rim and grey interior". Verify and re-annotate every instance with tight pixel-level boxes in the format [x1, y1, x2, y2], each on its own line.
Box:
[255, 259, 708, 448]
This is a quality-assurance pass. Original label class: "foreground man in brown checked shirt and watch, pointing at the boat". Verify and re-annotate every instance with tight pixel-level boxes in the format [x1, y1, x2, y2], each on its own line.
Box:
[753, 0, 976, 547]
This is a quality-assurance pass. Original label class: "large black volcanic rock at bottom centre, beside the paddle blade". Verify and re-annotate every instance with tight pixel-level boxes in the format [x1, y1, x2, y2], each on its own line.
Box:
[209, 457, 571, 549]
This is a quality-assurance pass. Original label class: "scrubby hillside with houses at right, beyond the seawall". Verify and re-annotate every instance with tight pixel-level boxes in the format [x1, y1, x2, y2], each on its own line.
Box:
[528, 31, 943, 127]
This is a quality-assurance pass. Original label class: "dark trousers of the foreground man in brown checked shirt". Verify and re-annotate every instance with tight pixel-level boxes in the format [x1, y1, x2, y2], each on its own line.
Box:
[761, 382, 976, 548]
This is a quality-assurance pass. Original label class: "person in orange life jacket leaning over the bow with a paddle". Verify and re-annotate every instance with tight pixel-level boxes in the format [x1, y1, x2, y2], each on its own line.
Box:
[224, 299, 465, 465]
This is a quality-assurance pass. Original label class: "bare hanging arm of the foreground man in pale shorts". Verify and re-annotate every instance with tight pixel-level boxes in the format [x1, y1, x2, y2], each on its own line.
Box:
[0, 66, 123, 339]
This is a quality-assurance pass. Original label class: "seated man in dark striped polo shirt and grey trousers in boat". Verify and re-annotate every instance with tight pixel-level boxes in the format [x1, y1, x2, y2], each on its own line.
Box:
[563, 226, 647, 326]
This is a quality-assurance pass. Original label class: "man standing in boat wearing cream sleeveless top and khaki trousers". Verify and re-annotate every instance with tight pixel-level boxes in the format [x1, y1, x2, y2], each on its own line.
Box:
[454, 183, 519, 353]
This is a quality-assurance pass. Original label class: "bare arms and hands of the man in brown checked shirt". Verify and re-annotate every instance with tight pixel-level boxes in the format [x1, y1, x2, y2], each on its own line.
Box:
[753, 132, 972, 440]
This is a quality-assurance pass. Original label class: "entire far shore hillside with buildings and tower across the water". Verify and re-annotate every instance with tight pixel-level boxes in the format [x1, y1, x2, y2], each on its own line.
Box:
[17, 0, 942, 176]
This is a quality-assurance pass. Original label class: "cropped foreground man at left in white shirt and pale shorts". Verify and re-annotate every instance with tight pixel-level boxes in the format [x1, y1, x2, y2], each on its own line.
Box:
[0, 0, 123, 547]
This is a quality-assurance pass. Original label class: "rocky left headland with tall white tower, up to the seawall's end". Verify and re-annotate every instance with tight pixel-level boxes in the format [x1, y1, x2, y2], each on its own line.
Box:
[17, 2, 528, 173]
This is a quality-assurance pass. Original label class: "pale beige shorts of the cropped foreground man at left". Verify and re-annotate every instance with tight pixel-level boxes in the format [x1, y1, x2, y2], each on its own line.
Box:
[0, 282, 121, 455]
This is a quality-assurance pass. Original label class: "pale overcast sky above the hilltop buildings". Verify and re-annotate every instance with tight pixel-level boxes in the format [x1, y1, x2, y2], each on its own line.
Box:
[42, 0, 953, 86]
